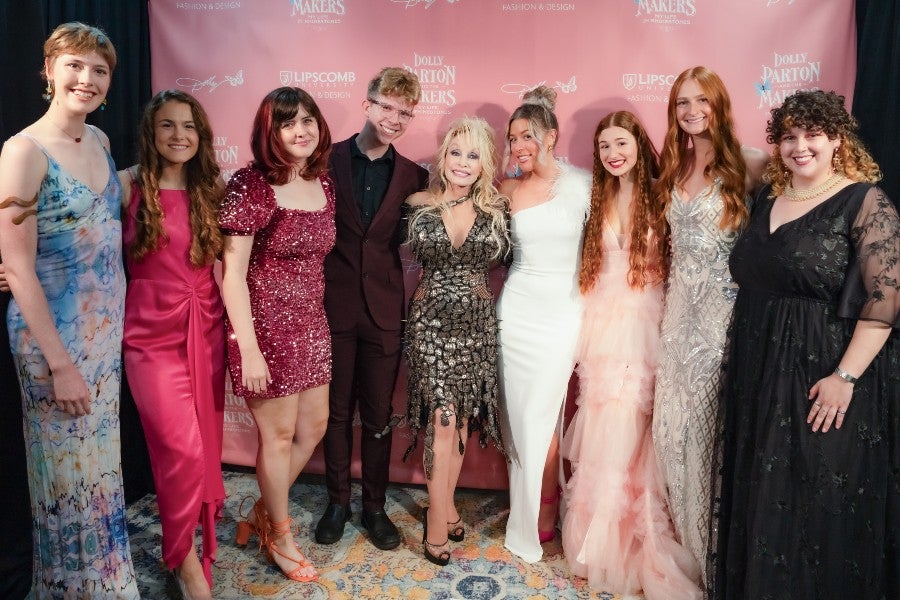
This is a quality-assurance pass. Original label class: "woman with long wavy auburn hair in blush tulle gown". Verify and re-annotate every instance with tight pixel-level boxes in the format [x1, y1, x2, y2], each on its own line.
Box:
[562, 111, 703, 600]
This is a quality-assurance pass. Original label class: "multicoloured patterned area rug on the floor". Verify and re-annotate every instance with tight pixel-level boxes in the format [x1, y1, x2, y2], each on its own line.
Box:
[128, 472, 617, 600]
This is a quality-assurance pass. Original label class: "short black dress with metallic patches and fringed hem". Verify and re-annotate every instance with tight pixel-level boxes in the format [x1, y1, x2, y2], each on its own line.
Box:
[404, 208, 505, 479]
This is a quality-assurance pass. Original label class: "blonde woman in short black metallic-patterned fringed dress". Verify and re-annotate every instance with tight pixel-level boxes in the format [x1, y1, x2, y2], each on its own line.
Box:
[406, 118, 509, 565]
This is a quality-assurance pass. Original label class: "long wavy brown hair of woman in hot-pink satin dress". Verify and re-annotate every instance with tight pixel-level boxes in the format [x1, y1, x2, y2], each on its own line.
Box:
[129, 90, 224, 267]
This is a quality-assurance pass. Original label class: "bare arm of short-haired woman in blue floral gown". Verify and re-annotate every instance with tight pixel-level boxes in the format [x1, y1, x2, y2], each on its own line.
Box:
[0, 138, 91, 416]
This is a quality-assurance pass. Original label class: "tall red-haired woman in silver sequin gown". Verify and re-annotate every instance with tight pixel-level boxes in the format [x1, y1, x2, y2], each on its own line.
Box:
[653, 67, 766, 585]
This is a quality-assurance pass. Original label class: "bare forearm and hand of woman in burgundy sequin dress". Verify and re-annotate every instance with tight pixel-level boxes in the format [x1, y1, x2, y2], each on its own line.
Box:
[222, 235, 272, 392]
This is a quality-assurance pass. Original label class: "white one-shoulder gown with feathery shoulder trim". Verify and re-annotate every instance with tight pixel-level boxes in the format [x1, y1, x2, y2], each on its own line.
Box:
[497, 163, 591, 563]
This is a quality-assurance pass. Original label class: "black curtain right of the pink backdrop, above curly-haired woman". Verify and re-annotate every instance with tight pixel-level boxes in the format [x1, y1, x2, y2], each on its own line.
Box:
[853, 0, 900, 206]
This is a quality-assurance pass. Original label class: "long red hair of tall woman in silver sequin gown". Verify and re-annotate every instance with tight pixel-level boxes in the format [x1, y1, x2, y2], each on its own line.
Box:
[655, 66, 750, 230]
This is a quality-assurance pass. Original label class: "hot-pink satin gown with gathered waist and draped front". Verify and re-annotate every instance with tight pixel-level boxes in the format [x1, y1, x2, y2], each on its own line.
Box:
[123, 186, 225, 585]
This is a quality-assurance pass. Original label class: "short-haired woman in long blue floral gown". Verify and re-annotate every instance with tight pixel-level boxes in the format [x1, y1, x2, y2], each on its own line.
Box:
[0, 23, 139, 600]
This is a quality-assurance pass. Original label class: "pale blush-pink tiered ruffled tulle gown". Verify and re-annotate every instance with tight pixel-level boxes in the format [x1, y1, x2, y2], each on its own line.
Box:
[562, 226, 703, 600]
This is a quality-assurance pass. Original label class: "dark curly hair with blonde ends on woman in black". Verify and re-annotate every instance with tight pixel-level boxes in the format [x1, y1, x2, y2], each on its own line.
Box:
[764, 90, 881, 198]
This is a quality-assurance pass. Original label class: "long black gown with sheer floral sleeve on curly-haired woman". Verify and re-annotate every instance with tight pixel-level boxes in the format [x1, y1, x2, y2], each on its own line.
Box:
[716, 183, 900, 600]
